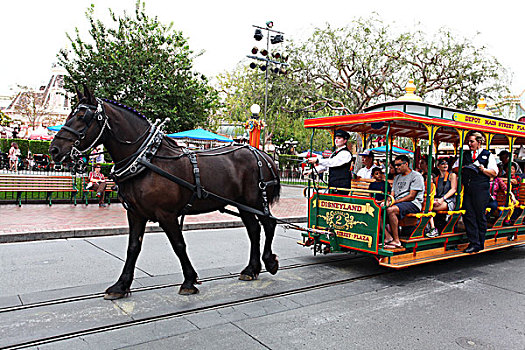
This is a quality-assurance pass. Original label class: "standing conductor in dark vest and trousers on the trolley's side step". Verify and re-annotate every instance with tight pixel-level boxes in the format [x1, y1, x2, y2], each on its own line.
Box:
[453, 132, 498, 253]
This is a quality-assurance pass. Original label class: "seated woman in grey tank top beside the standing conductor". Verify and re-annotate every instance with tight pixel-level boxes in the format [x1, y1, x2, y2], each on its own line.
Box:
[425, 159, 458, 237]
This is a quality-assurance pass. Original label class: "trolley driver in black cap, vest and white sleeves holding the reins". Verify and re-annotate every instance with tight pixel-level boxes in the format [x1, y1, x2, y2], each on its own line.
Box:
[305, 130, 352, 194]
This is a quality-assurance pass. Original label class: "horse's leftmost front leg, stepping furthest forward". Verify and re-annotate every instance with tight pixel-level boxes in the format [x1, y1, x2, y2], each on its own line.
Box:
[104, 210, 147, 300]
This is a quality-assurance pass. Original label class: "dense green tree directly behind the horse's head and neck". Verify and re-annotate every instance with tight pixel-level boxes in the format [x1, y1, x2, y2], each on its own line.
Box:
[57, 0, 217, 132]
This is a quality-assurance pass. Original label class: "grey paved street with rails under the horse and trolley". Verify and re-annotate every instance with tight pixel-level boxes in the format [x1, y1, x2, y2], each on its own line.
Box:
[0, 224, 525, 349]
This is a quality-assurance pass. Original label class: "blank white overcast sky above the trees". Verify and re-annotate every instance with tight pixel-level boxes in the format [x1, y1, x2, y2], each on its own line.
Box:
[0, 0, 525, 99]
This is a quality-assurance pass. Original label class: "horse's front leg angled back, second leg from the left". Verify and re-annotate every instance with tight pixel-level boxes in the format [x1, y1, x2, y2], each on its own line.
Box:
[159, 216, 199, 295]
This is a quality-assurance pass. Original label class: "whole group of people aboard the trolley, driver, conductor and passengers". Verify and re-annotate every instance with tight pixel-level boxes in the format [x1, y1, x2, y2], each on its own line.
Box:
[305, 130, 523, 253]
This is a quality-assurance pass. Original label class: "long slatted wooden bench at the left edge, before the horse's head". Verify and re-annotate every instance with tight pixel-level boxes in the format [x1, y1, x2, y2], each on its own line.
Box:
[0, 175, 78, 207]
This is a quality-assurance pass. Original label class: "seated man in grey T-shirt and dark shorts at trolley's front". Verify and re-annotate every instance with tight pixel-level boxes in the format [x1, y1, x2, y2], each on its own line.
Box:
[384, 155, 425, 249]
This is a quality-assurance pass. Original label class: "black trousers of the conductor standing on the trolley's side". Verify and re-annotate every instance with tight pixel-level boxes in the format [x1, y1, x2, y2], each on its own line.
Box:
[463, 183, 490, 249]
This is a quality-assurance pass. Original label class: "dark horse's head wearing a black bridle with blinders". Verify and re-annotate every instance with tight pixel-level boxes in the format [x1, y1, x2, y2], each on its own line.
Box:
[49, 86, 108, 162]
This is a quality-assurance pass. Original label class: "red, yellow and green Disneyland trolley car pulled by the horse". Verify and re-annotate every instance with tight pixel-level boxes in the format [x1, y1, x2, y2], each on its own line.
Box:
[298, 89, 525, 269]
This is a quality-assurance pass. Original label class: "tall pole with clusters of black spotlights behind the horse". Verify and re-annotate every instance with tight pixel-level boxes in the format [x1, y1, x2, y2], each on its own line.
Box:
[246, 21, 288, 150]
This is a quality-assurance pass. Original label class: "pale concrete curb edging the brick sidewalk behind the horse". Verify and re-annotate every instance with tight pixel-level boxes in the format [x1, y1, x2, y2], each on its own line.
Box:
[0, 216, 307, 244]
